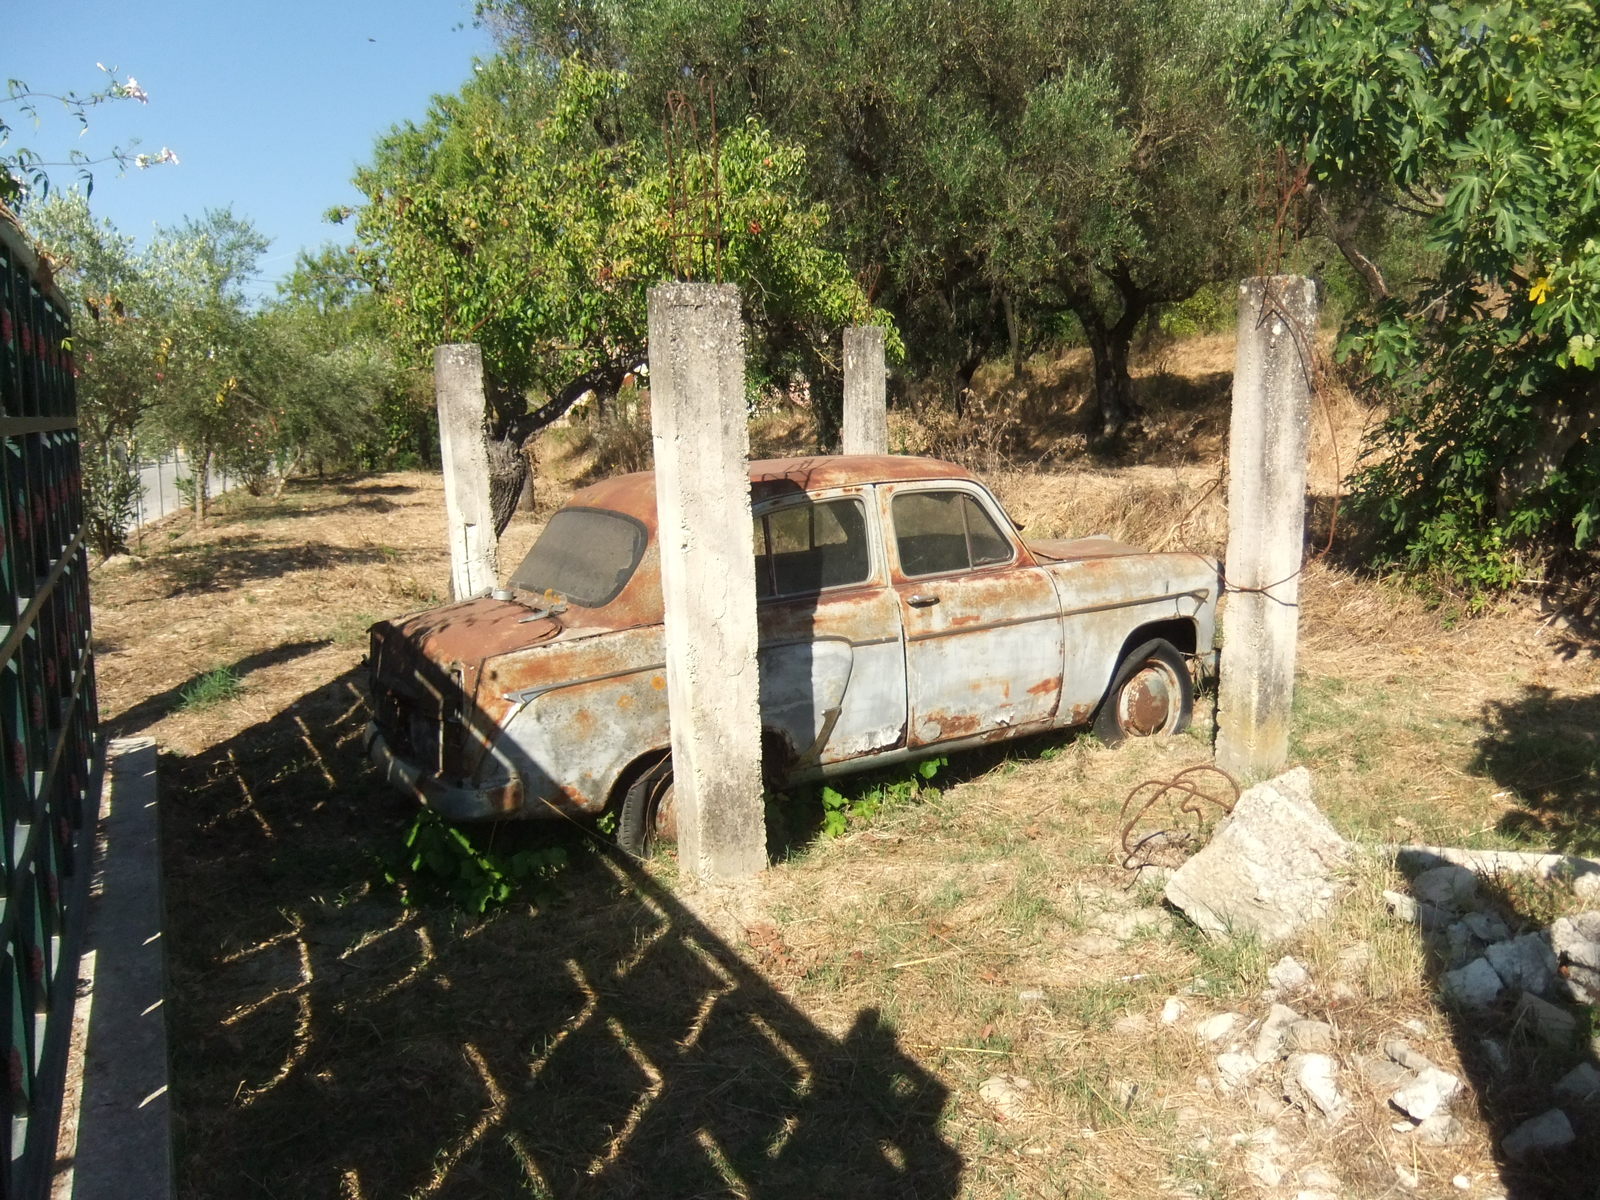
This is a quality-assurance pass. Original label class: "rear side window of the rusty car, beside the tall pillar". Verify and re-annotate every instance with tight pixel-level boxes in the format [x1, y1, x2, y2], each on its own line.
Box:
[755, 499, 872, 600]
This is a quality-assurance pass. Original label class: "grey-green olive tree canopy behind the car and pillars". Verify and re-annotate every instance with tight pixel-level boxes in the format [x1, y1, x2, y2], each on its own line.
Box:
[480, 0, 1250, 438]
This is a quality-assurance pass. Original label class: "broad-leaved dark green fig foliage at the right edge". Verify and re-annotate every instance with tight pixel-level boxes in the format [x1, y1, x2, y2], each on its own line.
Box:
[1243, 0, 1600, 589]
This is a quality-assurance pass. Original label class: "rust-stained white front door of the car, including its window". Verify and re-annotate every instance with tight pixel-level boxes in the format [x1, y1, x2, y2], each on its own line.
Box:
[878, 483, 1064, 747]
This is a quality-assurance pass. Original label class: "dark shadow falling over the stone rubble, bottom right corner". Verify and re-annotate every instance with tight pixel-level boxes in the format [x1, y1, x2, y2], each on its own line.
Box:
[1402, 851, 1600, 1200]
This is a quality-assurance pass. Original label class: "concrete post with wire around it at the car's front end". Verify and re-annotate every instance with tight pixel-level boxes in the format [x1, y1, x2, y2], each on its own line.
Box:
[1216, 275, 1318, 779]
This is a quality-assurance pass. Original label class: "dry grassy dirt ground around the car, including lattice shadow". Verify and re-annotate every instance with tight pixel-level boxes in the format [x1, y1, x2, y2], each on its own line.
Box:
[93, 356, 1600, 1200]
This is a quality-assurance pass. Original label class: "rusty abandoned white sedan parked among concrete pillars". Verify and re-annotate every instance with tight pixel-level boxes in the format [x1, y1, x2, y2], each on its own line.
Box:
[368, 456, 1221, 851]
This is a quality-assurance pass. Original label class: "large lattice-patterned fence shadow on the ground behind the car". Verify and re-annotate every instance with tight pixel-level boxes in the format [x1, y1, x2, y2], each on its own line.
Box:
[162, 672, 962, 1200]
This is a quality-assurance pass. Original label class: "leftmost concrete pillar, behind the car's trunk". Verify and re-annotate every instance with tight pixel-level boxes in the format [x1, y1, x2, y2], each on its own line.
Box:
[434, 344, 499, 600]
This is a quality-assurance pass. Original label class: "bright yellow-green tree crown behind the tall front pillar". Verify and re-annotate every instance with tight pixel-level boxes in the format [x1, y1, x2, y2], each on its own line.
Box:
[348, 51, 893, 438]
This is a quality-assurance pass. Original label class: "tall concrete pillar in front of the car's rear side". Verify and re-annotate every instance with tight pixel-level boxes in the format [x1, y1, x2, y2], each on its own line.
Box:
[650, 283, 766, 880]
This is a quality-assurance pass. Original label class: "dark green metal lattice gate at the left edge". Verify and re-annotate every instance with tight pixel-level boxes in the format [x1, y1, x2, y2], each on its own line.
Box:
[0, 216, 101, 1200]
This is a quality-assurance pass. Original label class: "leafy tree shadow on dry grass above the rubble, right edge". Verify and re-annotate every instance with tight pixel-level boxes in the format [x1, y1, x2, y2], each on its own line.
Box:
[1472, 686, 1600, 854]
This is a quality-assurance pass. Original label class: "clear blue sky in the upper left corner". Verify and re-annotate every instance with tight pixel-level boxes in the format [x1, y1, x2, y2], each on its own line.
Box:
[0, 0, 491, 294]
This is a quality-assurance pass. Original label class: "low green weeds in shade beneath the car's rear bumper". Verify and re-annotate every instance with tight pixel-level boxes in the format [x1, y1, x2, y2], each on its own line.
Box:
[384, 808, 566, 914]
